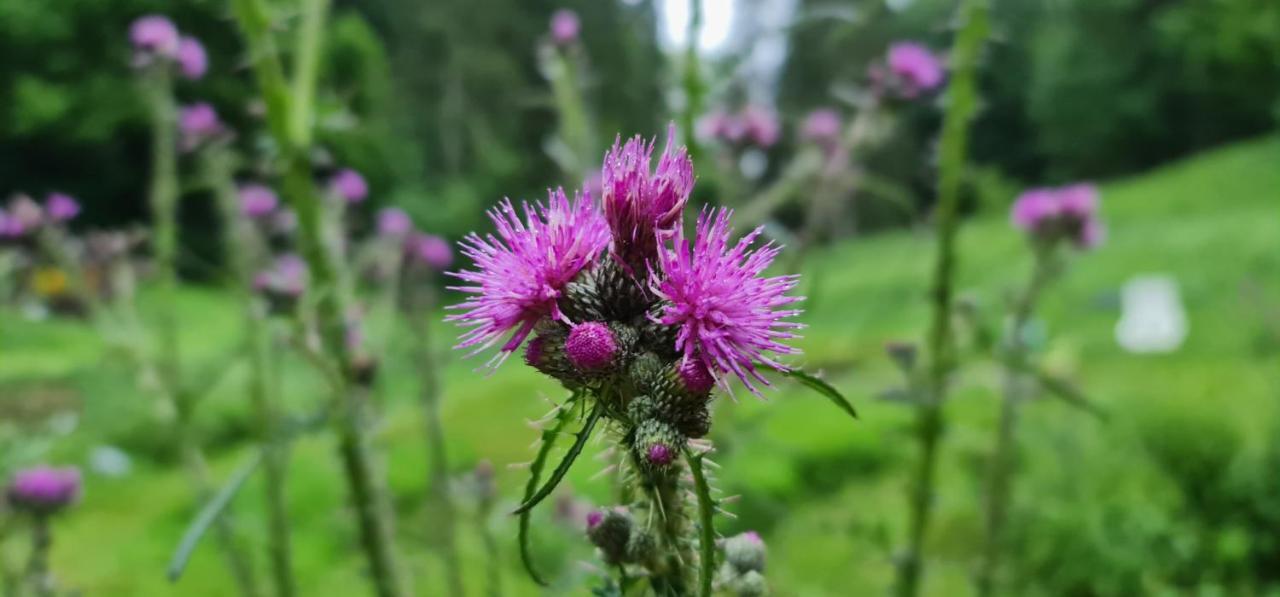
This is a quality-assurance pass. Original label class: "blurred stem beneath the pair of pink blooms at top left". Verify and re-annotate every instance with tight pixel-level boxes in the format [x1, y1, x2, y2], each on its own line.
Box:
[143, 65, 257, 596]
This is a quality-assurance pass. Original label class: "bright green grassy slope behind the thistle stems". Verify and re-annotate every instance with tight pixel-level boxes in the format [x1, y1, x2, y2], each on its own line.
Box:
[0, 137, 1280, 596]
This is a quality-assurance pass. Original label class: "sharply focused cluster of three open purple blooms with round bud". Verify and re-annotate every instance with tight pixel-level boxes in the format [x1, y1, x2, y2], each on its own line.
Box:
[448, 124, 799, 392]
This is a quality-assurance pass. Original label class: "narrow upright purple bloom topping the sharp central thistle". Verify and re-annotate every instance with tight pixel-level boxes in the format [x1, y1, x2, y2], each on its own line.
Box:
[602, 127, 694, 268]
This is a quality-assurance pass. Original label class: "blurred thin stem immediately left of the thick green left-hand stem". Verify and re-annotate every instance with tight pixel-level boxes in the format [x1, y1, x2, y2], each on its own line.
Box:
[207, 146, 297, 597]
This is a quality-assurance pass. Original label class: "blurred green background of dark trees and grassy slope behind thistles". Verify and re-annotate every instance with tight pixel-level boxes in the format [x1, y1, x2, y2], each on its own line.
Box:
[0, 0, 1280, 596]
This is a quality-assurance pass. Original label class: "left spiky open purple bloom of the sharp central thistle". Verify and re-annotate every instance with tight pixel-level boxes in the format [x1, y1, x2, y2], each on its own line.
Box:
[445, 188, 609, 366]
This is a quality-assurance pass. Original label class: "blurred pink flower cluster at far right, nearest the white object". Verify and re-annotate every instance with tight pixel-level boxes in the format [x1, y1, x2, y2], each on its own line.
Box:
[1010, 183, 1103, 249]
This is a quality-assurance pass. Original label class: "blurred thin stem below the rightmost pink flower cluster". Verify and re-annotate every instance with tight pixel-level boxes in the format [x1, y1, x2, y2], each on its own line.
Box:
[977, 246, 1055, 597]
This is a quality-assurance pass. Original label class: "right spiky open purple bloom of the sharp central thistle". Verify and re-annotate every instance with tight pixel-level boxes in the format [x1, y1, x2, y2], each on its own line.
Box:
[650, 209, 803, 395]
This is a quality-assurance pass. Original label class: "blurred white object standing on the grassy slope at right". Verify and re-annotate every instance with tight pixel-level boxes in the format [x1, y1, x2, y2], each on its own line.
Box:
[1116, 275, 1187, 352]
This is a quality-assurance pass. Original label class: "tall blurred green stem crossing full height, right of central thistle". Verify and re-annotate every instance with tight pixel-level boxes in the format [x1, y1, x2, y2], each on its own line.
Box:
[895, 0, 987, 597]
